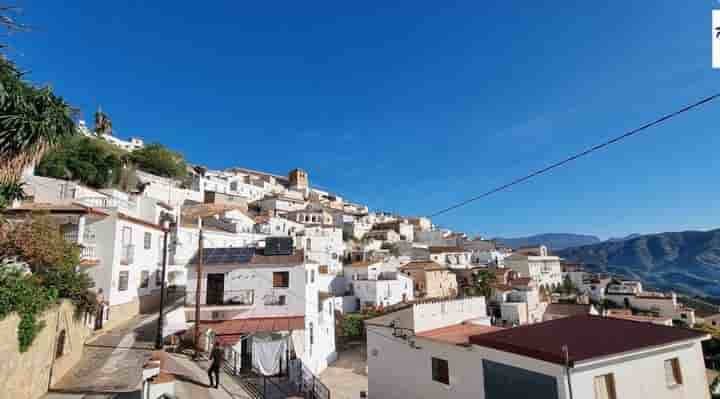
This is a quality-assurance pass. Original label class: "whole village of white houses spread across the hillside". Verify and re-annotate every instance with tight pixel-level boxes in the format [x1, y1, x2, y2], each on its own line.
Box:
[4, 112, 720, 399]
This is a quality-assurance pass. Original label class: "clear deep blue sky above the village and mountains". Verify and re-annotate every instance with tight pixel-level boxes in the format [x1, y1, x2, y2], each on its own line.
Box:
[10, 0, 720, 238]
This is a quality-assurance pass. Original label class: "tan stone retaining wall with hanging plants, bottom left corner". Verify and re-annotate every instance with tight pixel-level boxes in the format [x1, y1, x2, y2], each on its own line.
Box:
[0, 301, 93, 399]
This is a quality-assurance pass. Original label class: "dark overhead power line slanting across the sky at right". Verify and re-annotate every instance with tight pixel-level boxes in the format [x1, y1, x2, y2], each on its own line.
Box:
[429, 93, 720, 217]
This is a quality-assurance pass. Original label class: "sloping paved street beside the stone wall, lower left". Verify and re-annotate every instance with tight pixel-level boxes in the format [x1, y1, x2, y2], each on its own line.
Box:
[49, 316, 156, 399]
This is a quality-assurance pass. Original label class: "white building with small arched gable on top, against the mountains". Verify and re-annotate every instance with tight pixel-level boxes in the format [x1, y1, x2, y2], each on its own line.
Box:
[505, 246, 562, 288]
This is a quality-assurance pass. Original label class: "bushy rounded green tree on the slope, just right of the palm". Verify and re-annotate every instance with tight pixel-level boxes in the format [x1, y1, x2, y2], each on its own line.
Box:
[36, 136, 125, 188]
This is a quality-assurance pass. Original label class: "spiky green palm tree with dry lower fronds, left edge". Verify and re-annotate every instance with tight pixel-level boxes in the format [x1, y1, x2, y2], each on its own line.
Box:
[0, 55, 77, 184]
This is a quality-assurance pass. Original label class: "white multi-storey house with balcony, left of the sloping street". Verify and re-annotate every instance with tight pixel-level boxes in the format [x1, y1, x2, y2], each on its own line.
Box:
[4, 199, 173, 328]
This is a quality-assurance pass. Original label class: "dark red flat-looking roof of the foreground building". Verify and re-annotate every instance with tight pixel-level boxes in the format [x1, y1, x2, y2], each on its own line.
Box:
[470, 315, 707, 364]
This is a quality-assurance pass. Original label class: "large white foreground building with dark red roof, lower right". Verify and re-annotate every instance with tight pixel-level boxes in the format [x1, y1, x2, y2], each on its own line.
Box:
[367, 314, 709, 399]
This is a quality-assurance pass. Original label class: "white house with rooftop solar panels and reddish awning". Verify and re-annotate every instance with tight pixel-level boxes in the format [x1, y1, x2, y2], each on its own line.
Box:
[185, 248, 336, 374]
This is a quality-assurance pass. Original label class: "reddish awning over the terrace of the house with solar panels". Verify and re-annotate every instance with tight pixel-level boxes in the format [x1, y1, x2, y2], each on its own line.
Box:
[200, 316, 305, 345]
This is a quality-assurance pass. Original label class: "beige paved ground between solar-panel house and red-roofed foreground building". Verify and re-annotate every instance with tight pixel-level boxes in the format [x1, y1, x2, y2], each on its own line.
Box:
[320, 342, 368, 399]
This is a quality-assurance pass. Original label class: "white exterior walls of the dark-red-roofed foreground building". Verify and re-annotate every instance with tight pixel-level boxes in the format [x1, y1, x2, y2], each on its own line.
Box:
[367, 326, 709, 399]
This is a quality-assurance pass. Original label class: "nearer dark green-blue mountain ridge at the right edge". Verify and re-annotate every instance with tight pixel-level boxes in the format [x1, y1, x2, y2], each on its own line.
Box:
[555, 229, 720, 298]
